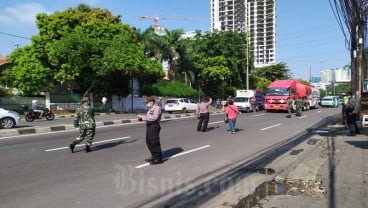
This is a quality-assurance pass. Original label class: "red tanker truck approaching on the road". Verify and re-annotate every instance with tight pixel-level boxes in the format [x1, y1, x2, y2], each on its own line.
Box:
[265, 79, 319, 110]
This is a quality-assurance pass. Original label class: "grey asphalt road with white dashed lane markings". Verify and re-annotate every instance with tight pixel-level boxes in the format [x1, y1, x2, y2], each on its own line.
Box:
[0, 108, 340, 208]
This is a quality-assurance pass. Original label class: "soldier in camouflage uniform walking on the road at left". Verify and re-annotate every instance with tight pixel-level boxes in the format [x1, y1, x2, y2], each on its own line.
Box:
[69, 97, 96, 153]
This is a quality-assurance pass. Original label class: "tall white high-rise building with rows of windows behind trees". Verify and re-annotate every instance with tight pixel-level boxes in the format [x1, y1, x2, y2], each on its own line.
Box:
[210, 0, 276, 68]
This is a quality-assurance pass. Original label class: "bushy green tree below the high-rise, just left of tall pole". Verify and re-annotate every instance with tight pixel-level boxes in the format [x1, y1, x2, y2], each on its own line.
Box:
[177, 31, 246, 97]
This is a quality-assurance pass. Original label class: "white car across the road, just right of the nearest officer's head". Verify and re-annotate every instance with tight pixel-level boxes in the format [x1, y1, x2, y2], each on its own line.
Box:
[164, 98, 197, 113]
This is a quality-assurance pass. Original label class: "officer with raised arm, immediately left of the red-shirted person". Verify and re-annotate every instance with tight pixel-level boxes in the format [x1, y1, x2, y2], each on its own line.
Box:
[196, 97, 212, 132]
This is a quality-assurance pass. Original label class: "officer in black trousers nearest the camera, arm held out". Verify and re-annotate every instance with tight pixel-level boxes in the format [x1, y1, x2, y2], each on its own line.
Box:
[137, 97, 163, 165]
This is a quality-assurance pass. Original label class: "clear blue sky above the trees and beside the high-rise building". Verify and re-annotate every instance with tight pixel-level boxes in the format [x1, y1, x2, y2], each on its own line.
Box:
[0, 0, 350, 80]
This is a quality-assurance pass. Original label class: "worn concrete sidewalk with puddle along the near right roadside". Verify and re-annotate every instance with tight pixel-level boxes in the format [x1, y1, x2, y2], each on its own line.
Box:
[201, 128, 368, 208]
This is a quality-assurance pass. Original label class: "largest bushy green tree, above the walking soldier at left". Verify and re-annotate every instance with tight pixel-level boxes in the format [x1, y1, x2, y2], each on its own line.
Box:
[1, 4, 163, 96]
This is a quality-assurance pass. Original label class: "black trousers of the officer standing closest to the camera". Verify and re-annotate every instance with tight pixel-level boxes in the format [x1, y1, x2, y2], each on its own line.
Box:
[146, 122, 162, 159]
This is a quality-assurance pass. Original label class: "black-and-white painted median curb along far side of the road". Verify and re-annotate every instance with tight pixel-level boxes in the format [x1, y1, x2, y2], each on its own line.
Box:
[0, 111, 223, 138]
